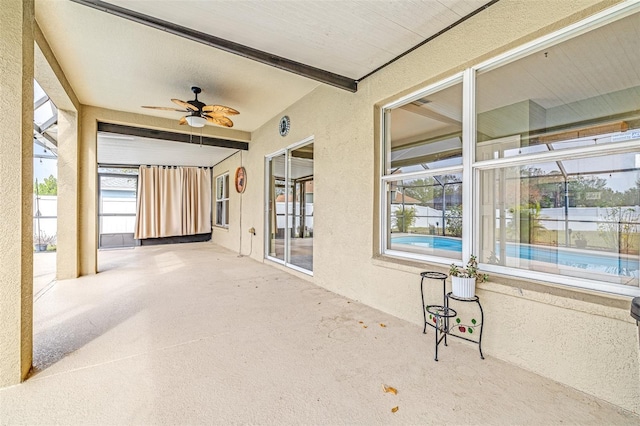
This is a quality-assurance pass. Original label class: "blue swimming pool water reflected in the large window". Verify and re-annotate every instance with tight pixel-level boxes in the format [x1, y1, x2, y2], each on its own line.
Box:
[391, 235, 640, 276]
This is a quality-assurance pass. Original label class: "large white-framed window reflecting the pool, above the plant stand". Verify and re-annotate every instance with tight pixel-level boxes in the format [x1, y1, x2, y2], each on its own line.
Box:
[381, 5, 640, 295]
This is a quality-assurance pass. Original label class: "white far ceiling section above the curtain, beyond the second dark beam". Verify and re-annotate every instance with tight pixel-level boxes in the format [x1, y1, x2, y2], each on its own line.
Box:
[98, 133, 237, 167]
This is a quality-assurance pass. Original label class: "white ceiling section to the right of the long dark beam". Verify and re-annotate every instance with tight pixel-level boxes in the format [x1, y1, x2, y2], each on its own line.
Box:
[105, 0, 489, 80]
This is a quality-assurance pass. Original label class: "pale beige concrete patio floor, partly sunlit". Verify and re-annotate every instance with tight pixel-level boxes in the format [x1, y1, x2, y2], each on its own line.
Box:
[0, 243, 640, 425]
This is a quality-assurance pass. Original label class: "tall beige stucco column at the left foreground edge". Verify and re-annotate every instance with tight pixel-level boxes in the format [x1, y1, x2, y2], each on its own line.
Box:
[0, 0, 34, 386]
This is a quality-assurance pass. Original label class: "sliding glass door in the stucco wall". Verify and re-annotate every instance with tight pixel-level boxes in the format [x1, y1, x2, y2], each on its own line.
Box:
[265, 141, 313, 272]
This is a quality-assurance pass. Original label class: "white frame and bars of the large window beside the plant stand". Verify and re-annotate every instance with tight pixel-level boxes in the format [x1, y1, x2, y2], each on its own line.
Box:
[378, 0, 640, 296]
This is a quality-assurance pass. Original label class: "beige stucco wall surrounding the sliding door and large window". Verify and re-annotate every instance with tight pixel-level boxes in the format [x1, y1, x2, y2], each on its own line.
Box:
[218, 0, 640, 413]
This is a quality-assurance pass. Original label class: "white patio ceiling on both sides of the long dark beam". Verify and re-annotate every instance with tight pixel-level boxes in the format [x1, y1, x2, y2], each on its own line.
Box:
[35, 0, 489, 163]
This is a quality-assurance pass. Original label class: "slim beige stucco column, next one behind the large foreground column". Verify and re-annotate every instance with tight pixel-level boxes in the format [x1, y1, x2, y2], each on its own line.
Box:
[56, 110, 80, 280]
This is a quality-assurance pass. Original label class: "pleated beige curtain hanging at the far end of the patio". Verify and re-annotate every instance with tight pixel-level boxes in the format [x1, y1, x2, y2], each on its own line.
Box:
[135, 166, 211, 239]
